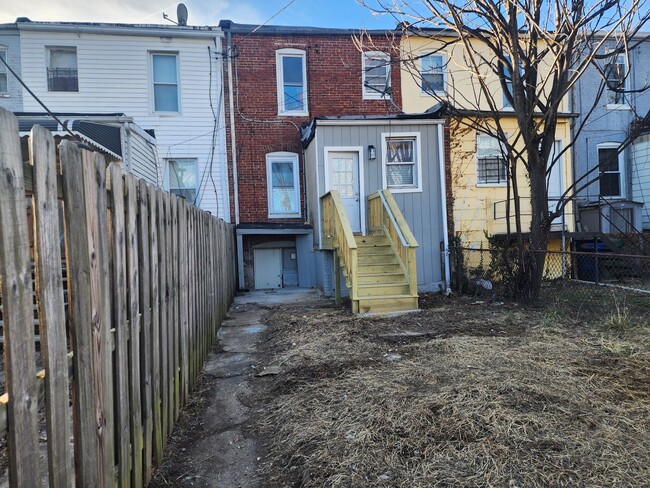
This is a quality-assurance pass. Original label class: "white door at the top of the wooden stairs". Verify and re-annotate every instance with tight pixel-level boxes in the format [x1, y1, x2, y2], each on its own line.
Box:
[327, 152, 361, 232]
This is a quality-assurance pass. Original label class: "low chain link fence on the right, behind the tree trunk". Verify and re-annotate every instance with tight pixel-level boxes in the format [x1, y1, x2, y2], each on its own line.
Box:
[450, 244, 650, 323]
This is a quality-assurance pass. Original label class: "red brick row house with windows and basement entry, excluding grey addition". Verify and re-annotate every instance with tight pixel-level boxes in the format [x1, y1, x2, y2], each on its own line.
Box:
[219, 20, 401, 289]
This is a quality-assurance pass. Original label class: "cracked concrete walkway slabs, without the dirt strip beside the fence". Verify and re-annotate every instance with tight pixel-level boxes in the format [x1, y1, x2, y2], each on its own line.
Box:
[172, 288, 324, 488]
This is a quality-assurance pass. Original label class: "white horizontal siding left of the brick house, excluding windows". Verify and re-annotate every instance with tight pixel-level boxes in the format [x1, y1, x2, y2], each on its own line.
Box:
[20, 30, 230, 220]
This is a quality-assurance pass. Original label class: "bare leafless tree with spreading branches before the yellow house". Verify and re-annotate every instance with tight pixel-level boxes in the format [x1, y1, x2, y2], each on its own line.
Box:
[357, 0, 650, 301]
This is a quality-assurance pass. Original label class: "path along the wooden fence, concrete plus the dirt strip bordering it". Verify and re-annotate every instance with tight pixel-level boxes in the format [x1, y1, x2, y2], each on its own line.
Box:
[150, 290, 322, 488]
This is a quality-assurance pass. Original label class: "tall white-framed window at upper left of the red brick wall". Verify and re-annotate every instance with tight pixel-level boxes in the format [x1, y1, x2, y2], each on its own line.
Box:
[275, 49, 308, 115]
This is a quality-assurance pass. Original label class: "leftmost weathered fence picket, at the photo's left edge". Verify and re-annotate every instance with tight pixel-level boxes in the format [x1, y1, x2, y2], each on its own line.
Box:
[0, 110, 39, 486]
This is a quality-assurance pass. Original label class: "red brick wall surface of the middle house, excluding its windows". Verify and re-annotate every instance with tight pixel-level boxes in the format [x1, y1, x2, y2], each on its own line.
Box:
[225, 33, 401, 223]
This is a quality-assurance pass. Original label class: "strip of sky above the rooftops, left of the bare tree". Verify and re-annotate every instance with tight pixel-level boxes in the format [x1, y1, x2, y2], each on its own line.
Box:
[0, 0, 396, 29]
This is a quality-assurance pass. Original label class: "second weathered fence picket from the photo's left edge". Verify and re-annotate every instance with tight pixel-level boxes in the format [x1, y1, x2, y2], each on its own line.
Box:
[30, 126, 74, 488]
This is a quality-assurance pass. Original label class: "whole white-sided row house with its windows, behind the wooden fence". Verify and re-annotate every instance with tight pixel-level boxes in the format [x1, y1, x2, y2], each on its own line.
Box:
[0, 18, 230, 221]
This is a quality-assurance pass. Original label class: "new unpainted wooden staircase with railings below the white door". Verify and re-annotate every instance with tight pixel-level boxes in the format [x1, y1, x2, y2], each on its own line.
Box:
[321, 190, 418, 313]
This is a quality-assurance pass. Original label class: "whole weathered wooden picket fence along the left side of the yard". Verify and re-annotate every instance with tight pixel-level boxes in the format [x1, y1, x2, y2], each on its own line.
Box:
[0, 110, 235, 487]
